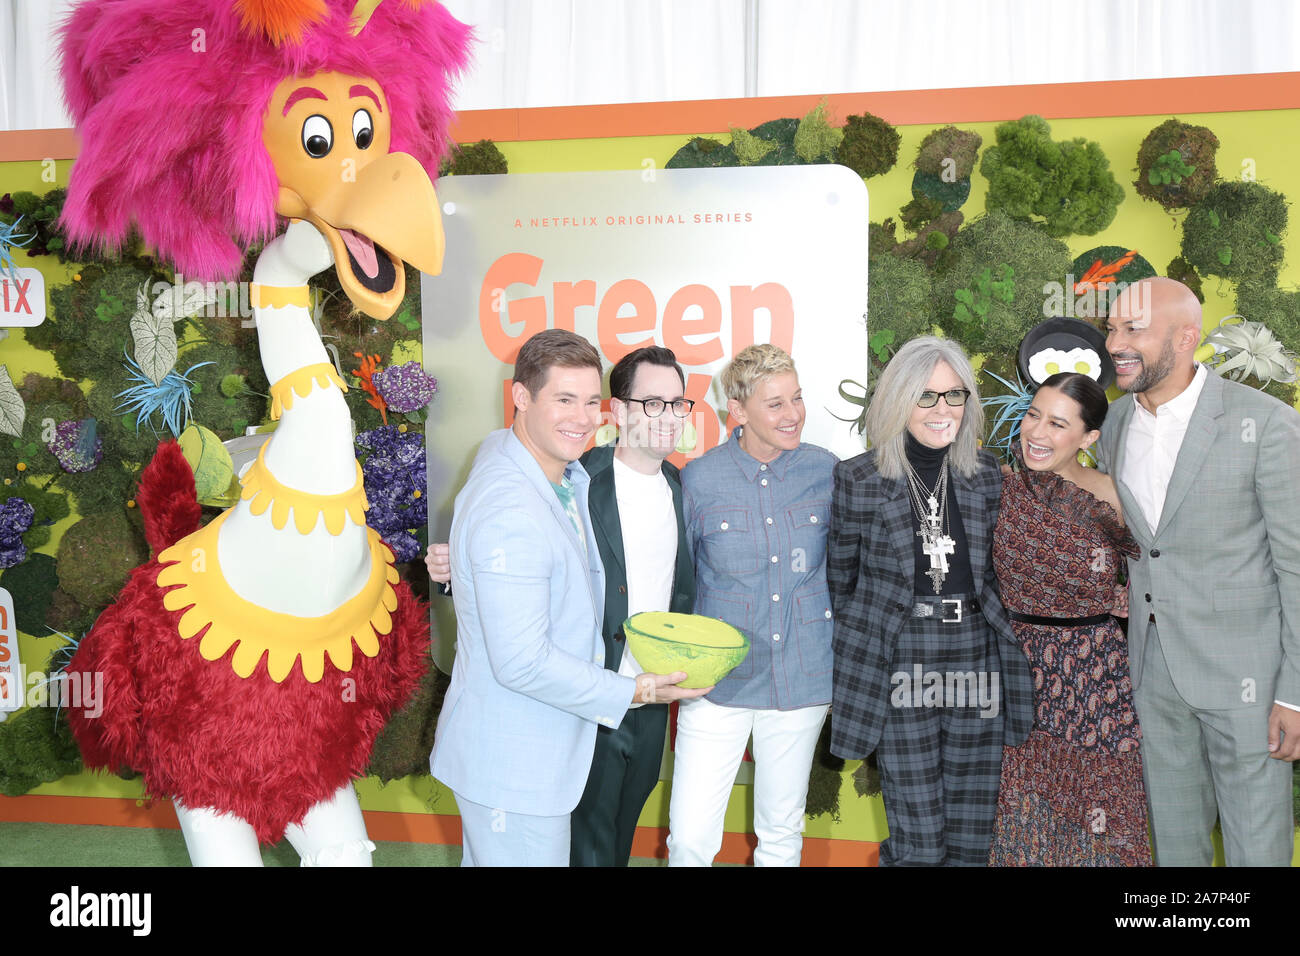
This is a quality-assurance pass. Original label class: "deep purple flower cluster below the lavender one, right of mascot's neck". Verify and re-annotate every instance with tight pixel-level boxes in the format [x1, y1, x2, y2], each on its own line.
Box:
[356, 425, 429, 561]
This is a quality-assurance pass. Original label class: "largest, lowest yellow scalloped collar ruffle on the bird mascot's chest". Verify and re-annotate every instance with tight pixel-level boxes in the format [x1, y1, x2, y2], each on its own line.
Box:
[157, 511, 398, 684]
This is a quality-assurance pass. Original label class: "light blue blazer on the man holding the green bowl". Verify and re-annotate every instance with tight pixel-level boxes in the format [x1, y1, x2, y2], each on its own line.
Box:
[429, 429, 634, 817]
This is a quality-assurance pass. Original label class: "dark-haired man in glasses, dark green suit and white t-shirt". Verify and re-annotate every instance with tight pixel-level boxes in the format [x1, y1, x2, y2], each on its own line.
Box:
[569, 347, 696, 866]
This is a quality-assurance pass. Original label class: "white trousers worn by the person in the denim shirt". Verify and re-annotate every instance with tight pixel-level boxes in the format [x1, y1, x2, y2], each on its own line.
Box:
[668, 697, 829, 866]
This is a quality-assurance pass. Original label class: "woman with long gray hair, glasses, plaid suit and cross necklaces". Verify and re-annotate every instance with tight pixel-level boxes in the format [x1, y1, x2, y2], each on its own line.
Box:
[827, 336, 1032, 866]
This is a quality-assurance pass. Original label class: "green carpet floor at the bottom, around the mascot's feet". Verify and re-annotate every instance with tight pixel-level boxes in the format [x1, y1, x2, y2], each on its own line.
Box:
[0, 823, 666, 868]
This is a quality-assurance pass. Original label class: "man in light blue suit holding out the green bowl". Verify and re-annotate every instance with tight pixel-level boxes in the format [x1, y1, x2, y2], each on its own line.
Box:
[429, 329, 707, 866]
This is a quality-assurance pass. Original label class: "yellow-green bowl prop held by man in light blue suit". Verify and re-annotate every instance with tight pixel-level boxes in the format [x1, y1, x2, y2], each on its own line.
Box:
[623, 611, 749, 688]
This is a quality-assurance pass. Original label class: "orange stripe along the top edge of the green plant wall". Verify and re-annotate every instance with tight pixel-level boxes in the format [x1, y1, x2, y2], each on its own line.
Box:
[0, 73, 1300, 161]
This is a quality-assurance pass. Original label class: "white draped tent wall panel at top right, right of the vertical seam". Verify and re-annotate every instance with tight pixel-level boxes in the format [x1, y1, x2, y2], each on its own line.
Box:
[755, 0, 1300, 96]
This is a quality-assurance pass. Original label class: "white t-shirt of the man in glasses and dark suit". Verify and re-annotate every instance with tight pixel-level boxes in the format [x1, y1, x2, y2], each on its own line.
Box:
[614, 458, 677, 706]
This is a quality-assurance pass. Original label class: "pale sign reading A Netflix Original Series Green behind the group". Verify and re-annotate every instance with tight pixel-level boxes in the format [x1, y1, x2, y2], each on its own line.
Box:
[421, 165, 868, 468]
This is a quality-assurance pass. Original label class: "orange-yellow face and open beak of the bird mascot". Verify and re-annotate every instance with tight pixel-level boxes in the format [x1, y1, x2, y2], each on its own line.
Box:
[263, 73, 445, 319]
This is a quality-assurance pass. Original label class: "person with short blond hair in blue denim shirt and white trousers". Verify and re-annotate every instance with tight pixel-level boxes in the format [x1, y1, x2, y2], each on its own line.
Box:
[668, 345, 836, 866]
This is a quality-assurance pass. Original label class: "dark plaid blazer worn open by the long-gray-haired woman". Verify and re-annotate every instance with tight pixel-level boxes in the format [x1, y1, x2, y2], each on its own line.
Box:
[827, 451, 1034, 760]
